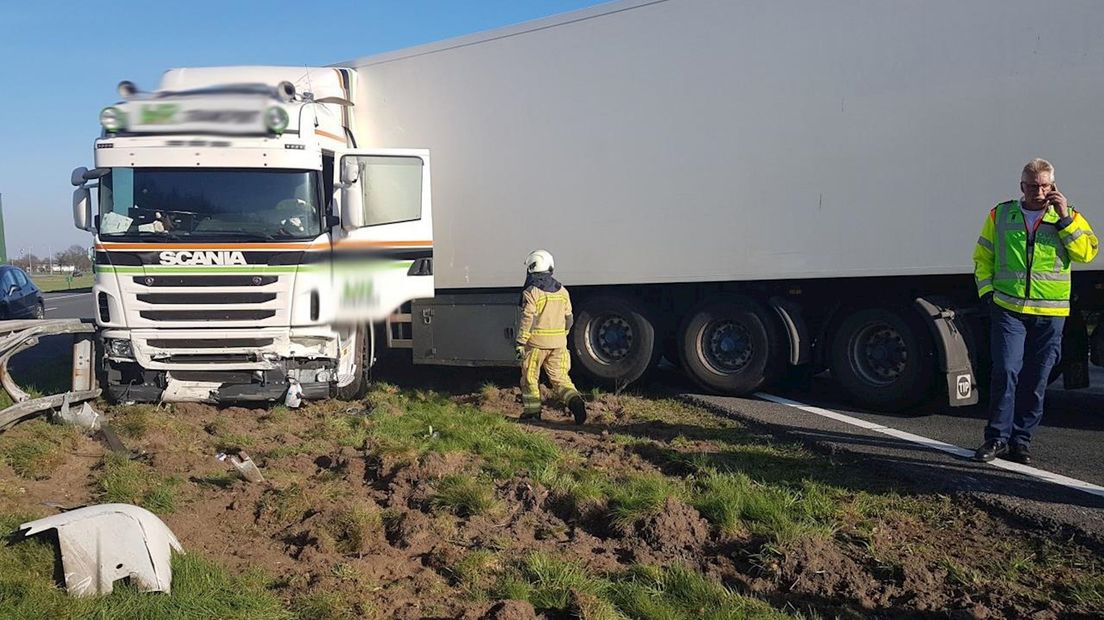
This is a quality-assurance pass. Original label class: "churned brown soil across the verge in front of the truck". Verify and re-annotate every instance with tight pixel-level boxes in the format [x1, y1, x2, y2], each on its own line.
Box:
[0, 370, 1102, 620]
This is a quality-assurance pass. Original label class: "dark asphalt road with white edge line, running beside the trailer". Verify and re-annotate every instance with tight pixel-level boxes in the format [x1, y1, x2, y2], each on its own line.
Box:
[21, 292, 1104, 533]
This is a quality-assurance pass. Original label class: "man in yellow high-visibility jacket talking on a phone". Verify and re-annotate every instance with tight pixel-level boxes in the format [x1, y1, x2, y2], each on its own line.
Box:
[974, 159, 1100, 464]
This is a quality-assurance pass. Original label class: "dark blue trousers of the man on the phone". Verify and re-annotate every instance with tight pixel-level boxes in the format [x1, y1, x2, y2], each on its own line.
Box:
[985, 303, 1065, 446]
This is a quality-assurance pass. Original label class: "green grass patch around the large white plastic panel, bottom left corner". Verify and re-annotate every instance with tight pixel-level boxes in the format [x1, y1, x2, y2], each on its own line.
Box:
[0, 514, 291, 620]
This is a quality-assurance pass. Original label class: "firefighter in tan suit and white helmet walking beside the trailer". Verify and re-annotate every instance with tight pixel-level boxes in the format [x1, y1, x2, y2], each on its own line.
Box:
[517, 249, 586, 424]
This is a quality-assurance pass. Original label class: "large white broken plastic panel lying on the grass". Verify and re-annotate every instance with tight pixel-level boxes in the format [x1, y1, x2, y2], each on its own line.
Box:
[20, 504, 184, 597]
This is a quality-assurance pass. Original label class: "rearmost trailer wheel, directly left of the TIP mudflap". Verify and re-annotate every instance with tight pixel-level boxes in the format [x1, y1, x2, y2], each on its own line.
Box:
[829, 308, 935, 411]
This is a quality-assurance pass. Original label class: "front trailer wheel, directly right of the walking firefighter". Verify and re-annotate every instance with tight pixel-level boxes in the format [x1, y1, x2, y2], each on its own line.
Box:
[569, 295, 660, 387]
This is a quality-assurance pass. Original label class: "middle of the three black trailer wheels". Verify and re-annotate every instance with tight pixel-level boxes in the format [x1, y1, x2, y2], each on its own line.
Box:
[679, 297, 789, 395]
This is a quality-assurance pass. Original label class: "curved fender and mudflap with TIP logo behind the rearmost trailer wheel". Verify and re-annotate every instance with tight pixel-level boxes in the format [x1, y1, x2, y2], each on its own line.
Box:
[914, 297, 978, 407]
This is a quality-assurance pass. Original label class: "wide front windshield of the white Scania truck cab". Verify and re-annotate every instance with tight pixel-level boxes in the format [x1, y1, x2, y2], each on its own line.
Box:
[99, 168, 321, 240]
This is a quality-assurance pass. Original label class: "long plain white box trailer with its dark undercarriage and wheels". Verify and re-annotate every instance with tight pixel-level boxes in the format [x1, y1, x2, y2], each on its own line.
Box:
[73, 0, 1104, 408]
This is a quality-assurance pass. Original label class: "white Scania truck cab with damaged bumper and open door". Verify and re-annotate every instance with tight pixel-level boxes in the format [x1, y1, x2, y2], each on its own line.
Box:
[72, 67, 433, 403]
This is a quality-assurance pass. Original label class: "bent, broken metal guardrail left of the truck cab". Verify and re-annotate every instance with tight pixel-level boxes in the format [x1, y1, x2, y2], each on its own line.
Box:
[0, 319, 100, 432]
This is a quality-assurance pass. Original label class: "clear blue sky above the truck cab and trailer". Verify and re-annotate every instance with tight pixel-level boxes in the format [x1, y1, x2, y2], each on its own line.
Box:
[0, 0, 601, 258]
